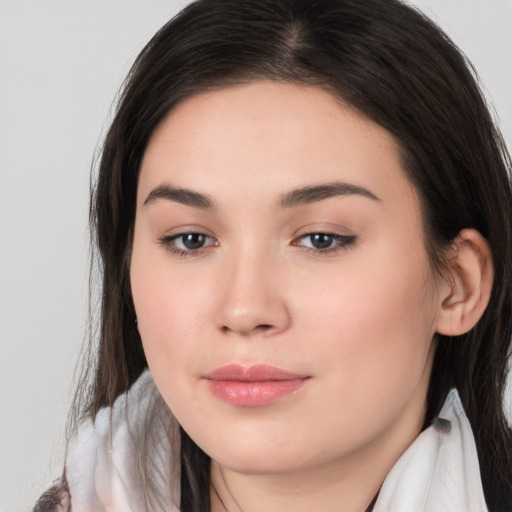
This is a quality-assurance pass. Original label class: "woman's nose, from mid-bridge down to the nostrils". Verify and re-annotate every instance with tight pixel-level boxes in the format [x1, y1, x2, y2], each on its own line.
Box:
[215, 247, 291, 336]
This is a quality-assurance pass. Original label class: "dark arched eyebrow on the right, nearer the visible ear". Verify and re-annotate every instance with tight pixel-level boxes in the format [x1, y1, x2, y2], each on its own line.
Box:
[279, 181, 380, 208]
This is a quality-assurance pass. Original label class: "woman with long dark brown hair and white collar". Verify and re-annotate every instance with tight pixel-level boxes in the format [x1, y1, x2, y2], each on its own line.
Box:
[36, 0, 512, 512]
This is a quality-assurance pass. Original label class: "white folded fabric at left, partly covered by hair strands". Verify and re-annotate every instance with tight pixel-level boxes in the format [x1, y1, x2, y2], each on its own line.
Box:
[66, 370, 180, 512]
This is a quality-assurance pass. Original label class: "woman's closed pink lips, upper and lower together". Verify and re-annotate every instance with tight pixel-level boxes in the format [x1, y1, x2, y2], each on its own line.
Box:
[203, 364, 309, 407]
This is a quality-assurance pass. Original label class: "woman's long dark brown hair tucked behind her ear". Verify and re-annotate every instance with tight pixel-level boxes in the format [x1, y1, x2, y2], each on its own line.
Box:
[75, 0, 512, 512]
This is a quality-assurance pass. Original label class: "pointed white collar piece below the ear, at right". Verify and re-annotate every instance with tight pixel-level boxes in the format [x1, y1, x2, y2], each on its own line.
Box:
[373, 389, 487, 512]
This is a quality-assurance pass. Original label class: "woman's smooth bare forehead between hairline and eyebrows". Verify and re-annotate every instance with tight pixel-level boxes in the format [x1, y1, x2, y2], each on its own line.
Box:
[139, 81, 411, 210]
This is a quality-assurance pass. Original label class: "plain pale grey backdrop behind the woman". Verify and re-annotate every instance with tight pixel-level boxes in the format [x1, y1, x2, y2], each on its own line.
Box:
[0, 0, 512, 512]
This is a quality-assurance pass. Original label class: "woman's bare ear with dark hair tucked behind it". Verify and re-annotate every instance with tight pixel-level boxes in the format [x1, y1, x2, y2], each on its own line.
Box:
[436, 229, 494, 336]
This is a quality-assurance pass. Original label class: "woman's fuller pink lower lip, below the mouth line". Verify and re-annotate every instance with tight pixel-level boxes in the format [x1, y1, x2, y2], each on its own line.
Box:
[207, 379, 308, 407]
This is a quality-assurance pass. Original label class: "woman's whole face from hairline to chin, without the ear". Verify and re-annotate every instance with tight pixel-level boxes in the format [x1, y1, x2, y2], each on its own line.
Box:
[130, 82, 439, 474]
